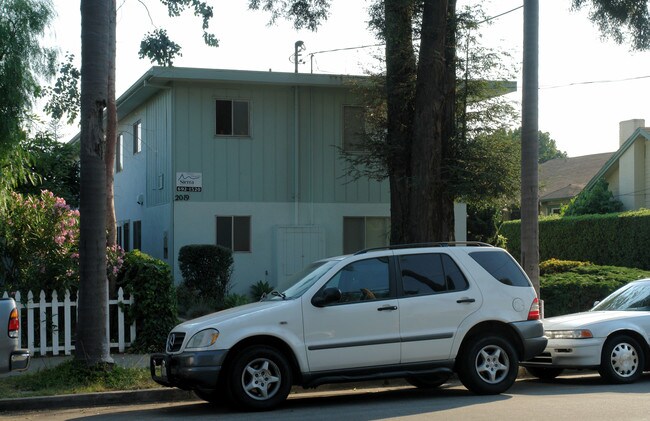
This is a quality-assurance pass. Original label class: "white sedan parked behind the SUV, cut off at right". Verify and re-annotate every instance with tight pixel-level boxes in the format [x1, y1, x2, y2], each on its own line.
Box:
[522, 279, 650, 383]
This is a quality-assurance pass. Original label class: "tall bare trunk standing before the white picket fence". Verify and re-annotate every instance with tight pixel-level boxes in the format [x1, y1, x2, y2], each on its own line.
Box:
[75, 0, 112, 365]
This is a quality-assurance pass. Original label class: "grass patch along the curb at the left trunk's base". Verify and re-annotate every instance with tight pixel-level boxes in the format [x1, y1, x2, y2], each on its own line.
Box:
[0, 359, 160, 398]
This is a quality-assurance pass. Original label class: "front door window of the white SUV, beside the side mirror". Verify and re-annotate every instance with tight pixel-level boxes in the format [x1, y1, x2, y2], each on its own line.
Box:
[322, 257, 390, 303]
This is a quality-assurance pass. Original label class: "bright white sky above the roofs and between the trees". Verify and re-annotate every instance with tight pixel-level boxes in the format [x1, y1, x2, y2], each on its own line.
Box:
[48, 0, 650, 157]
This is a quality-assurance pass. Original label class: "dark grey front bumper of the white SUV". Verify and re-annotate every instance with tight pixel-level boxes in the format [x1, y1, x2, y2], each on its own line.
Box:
[149, 349, 228, 390]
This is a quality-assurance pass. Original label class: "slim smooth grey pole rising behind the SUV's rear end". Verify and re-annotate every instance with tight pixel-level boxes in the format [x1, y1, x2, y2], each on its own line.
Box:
[521, 0, 541, 300]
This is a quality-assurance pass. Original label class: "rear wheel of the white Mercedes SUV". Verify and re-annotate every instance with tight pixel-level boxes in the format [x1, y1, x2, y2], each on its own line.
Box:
[458, 335, 519, 395]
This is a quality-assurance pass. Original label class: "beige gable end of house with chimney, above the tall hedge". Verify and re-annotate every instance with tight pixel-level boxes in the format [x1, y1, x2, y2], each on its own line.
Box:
[586, 119, 650, 210]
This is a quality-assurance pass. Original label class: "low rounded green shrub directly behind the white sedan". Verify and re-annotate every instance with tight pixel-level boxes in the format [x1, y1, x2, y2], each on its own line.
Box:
[540, 262, 650, 317]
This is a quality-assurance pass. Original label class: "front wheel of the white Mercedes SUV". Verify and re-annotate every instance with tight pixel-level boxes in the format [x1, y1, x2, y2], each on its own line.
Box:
[228, 345, 292, 411]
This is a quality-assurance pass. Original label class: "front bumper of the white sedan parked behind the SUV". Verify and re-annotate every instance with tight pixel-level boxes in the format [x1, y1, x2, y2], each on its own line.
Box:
[521, 338, 604, 368]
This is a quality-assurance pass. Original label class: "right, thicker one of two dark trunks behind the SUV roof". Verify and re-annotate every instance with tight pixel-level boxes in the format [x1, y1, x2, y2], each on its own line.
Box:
[409, 0, 456, 242]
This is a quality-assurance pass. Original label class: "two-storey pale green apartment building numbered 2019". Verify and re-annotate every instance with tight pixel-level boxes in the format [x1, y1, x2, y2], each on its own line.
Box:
[107, 67, 466, 293]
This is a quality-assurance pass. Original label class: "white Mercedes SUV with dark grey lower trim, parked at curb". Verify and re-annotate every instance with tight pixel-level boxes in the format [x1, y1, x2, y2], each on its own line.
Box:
[150, 243, 546, 410]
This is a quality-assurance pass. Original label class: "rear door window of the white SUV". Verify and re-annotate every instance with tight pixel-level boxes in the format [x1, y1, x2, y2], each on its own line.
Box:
[399, 253, 468, 296]
